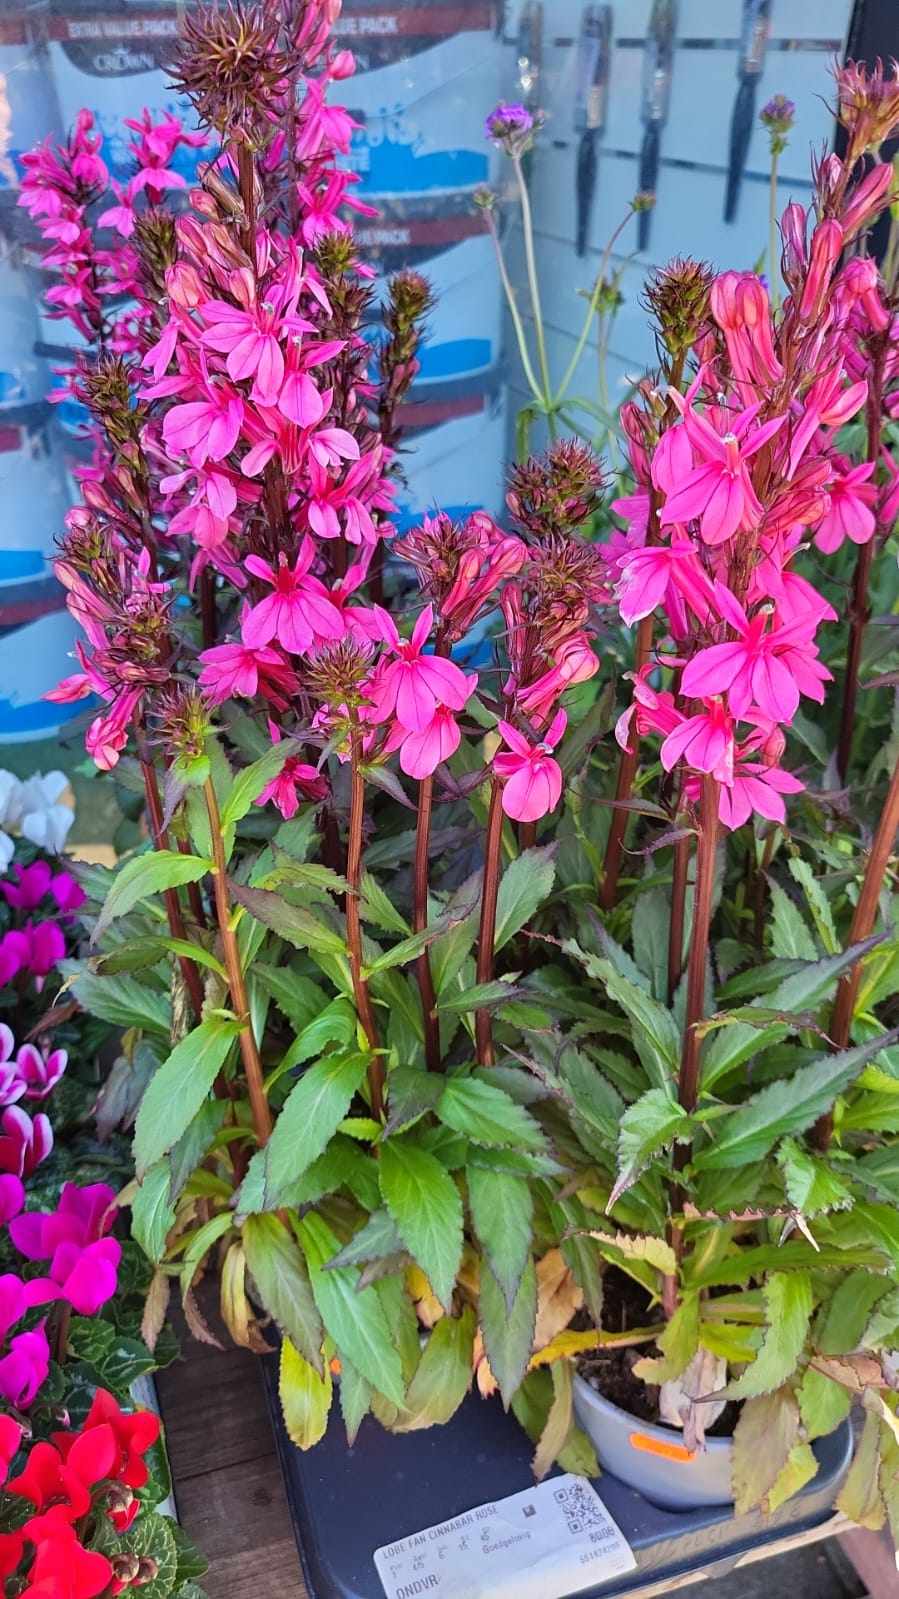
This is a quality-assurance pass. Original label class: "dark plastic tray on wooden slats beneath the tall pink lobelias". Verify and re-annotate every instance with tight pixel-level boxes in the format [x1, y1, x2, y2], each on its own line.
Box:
[262, 1359, 853, 1599]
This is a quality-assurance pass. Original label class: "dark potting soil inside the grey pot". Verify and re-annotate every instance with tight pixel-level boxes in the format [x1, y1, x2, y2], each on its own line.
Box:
[577, 1266, 739, 1438]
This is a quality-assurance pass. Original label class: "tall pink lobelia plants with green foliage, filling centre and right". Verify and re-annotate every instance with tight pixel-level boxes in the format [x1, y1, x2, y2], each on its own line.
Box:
[22, 3, 899, 1554]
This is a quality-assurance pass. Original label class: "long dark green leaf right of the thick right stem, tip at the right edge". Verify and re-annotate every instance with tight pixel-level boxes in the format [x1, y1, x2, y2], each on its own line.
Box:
[693, 1031, 899, 1172]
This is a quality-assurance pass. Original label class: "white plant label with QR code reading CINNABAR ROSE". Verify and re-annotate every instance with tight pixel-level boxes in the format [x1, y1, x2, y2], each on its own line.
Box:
[374, 1473, 637, 1599]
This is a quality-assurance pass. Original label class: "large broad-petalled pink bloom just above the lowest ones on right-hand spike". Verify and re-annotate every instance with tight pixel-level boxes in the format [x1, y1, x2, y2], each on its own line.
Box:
[681, 582, 830, 721]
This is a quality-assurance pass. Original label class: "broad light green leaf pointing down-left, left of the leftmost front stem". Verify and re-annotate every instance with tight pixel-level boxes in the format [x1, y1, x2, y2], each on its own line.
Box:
[134, 1017, 240, 1178]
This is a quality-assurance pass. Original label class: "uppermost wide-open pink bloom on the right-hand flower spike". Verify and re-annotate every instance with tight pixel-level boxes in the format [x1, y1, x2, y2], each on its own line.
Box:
[659, 392, 784, 544]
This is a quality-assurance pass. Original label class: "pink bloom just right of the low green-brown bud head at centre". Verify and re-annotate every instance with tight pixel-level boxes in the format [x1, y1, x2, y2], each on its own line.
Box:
[368, 604, 477, 732]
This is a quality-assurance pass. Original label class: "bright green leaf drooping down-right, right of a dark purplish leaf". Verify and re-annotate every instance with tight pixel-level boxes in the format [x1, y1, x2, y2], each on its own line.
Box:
[294, 1210, 406, 1406]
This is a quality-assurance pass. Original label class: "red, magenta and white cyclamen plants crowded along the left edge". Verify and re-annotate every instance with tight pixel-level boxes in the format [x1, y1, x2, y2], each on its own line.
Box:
[0, 793, 205, 1599]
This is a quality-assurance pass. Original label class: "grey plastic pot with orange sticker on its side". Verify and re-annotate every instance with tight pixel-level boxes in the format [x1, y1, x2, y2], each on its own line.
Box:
[574, 1377, 734, 1509]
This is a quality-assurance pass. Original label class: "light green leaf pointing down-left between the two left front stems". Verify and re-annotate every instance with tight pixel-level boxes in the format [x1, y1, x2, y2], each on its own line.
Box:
[266, 1054, 368, 1204]
